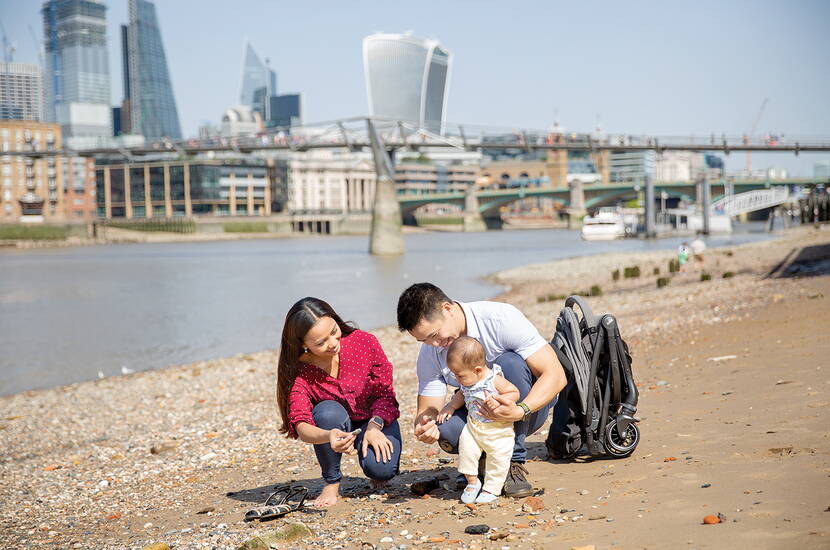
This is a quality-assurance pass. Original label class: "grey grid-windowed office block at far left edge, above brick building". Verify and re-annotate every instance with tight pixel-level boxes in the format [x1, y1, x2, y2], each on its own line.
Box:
[0, 63, 43, 121]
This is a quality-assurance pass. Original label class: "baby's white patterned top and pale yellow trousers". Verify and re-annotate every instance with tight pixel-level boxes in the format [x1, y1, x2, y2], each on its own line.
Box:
[458, 364, 516, 495]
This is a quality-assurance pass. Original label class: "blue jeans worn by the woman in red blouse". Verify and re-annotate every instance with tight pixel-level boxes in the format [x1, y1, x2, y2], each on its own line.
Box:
[311, 401, 401, 483]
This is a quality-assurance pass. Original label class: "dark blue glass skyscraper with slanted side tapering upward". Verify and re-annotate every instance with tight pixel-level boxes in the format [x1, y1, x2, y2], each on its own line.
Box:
[125, 0, 182, 139]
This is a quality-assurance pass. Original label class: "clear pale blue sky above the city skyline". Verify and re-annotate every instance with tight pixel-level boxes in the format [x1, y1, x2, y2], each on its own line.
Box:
[0, 0, 830, 176]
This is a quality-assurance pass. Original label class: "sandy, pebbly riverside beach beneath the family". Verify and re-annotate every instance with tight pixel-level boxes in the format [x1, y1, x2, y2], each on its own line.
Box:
[0, 226, 830, 550]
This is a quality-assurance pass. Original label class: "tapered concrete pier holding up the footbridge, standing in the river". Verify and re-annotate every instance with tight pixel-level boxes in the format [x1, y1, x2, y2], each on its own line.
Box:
[366, 119, 405, 256]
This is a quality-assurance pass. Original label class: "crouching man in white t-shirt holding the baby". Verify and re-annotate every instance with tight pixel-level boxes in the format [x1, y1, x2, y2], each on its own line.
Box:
[398, 283, 567, 497]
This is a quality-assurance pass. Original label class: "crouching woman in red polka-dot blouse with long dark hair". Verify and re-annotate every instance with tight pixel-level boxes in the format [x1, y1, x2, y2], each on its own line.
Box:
[277, 298, 401, 506]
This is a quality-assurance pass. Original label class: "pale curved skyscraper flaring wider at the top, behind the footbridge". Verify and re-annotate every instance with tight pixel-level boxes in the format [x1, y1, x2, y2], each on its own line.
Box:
[363, 33, 452, 132]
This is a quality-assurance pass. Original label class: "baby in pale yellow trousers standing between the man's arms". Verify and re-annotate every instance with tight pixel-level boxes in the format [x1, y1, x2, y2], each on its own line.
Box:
[438, 336, 519, 504]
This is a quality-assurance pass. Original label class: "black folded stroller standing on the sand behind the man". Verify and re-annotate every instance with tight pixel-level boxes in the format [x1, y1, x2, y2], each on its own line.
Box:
[545, 296, 640, 458]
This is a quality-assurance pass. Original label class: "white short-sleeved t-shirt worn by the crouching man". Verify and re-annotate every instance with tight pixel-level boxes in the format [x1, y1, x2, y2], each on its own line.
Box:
[417, 302, 548, 397]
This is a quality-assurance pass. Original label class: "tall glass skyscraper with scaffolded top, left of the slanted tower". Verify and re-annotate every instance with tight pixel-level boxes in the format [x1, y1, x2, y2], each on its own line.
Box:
[41, 0, 112, 145]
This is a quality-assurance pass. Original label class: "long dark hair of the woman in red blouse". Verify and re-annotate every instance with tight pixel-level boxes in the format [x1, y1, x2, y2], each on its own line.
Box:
[277, 296, 356, 434]
